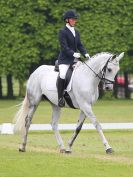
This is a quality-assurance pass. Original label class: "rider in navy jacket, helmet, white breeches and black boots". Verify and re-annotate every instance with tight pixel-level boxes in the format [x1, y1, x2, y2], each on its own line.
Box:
[57, 10, 90, 107]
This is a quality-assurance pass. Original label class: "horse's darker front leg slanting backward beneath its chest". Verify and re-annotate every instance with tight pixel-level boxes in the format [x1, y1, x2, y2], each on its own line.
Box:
[66, 111, 86, 153]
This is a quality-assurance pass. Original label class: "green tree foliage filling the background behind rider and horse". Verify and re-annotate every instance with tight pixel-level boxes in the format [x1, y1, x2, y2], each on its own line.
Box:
[0, 0, 133, 80]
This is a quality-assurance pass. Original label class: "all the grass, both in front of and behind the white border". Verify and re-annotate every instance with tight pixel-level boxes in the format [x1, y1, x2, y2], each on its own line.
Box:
[0, 100, 133, 177]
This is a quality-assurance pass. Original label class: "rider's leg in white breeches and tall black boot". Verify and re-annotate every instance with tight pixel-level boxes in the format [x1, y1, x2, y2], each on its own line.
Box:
[57, 64, 70, 107]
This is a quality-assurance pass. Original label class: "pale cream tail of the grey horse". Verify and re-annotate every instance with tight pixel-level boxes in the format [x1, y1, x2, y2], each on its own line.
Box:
[14, 93, 29, 135]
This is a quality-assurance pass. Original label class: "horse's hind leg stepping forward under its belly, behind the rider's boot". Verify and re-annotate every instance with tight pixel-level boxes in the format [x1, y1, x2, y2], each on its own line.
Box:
[51, 105, 65, 152]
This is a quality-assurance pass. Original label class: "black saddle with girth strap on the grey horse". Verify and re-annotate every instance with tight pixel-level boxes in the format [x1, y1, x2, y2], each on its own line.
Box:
[54, 60, 76, 109]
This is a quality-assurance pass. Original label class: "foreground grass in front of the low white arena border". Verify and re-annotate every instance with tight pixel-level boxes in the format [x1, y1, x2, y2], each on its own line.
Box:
[0, 131, 133, 177]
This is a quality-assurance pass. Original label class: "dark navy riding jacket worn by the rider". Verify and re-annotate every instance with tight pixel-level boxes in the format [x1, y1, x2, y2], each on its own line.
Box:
[58, 26, 87, 64]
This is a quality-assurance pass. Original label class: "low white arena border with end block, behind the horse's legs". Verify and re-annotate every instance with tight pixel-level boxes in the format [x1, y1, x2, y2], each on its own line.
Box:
[0, 123, 133, 134]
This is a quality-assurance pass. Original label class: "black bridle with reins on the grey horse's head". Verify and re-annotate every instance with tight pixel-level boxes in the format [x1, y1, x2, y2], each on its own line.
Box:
[83, 56, 115, 84]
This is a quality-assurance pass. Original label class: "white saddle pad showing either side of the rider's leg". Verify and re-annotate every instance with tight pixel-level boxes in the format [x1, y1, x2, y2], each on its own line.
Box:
[46, 61, 82, 92]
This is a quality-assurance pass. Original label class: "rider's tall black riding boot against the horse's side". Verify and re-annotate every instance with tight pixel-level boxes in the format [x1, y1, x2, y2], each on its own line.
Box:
[57, 77, 65, 107]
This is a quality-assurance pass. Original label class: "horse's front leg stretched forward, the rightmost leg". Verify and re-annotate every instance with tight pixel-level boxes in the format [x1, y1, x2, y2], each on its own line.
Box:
[83, 104, 113, 153]
